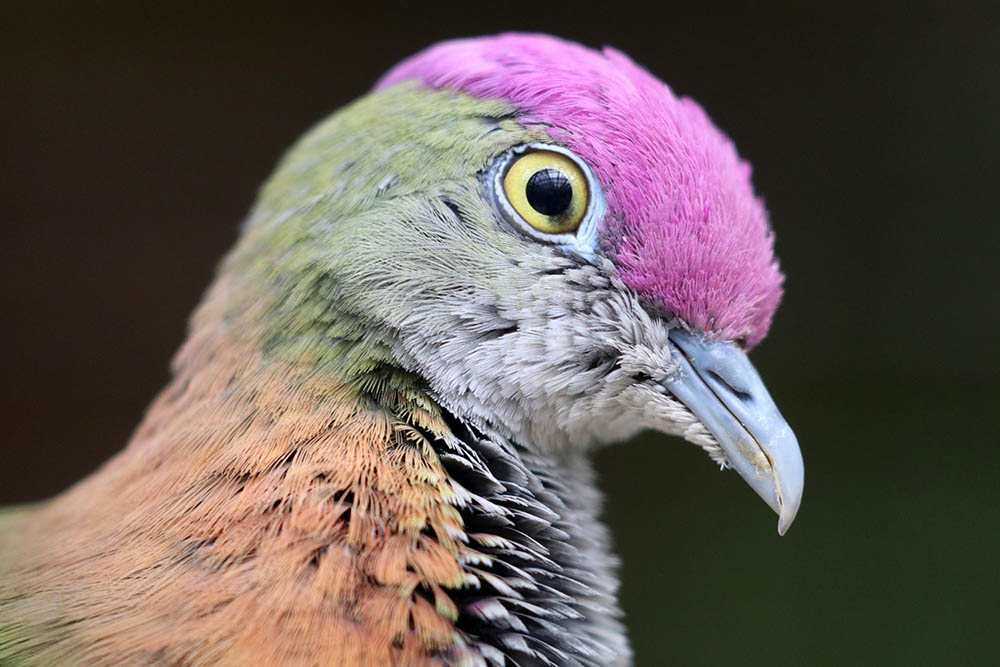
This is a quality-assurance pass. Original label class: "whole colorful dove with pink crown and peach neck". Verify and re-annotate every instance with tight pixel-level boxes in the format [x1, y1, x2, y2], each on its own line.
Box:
[0, 33, 804, 667]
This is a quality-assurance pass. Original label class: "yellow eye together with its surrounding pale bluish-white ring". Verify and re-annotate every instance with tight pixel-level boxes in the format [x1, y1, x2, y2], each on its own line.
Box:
[488, 143, 604, 249]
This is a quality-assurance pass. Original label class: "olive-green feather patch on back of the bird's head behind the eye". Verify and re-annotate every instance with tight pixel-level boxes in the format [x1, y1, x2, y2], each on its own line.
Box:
[206, 81, 547, 382]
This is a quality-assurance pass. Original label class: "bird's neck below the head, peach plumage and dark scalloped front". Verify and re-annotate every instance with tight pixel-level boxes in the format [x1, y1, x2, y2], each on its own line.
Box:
[7, 276, 628, 665]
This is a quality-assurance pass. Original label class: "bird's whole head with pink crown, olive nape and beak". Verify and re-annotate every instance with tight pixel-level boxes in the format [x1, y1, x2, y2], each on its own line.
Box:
[225, 34, 802, 527]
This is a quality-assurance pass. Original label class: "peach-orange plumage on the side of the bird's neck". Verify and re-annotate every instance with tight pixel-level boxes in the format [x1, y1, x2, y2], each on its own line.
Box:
[2, 270, 468, 665]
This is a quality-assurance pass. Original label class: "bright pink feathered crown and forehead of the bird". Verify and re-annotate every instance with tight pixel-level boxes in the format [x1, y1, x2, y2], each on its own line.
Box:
[376, 33, 783, 347]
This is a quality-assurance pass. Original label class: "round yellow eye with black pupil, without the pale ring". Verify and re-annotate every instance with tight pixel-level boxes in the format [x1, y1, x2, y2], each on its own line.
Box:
[503, 150, 589, 234]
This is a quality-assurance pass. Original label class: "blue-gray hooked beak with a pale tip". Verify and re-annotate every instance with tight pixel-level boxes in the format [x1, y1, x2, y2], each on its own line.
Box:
[663, 329, 805, 535]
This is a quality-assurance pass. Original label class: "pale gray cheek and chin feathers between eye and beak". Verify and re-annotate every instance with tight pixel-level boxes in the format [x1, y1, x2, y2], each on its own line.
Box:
[396, 252, 714, 454]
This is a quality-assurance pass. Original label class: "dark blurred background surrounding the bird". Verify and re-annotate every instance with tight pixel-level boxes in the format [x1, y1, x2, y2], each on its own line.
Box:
[0, 2, 1000, 667]
